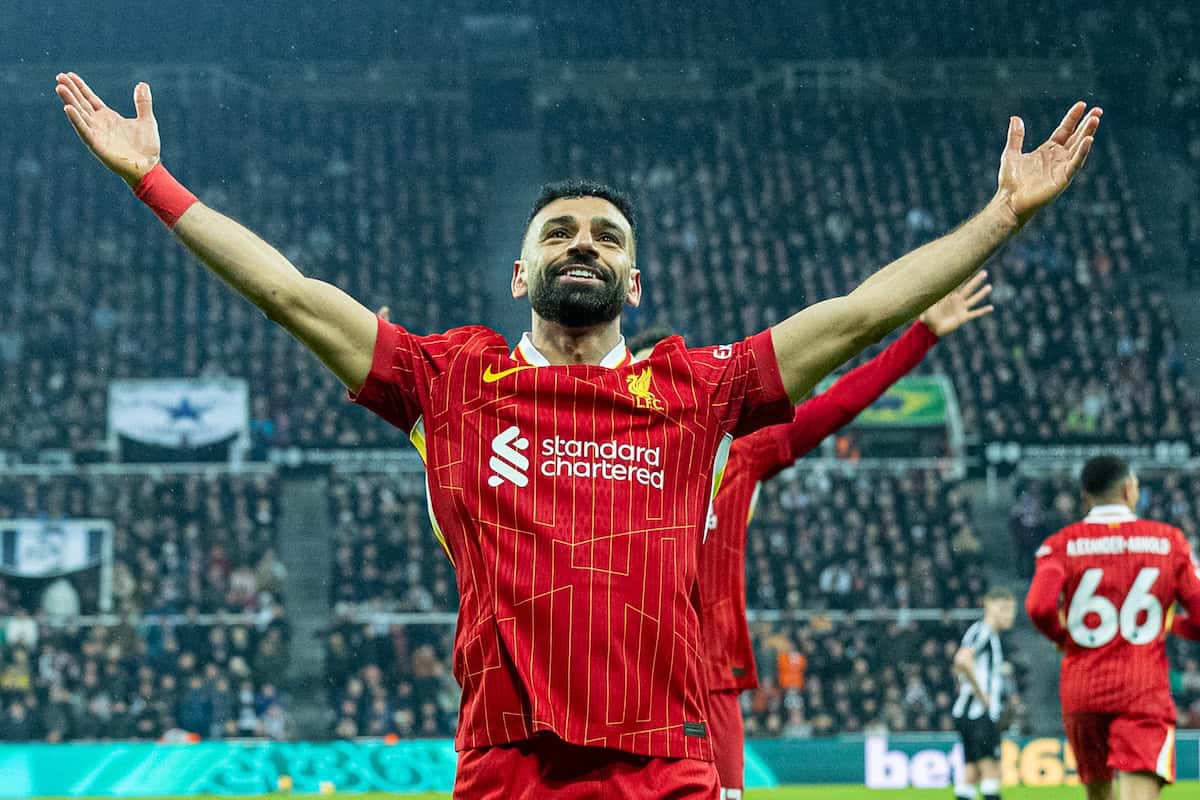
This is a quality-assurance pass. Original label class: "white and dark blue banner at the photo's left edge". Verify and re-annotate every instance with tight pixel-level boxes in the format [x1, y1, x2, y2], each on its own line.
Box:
[0, 519, 113, 578]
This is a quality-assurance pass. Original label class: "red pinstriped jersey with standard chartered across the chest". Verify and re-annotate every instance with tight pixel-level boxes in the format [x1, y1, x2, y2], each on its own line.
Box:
[354, 320, 791, 760]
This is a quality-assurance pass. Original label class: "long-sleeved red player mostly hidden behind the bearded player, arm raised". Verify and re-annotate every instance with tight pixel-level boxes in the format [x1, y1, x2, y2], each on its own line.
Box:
[630, 271, 992, 800]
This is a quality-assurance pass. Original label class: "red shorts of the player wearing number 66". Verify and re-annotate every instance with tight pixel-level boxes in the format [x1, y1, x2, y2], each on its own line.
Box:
[1062, 711, 1175, 783]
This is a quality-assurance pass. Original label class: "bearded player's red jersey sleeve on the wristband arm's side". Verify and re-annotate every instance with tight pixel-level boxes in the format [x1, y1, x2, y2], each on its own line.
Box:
[349, 318, 467, 433]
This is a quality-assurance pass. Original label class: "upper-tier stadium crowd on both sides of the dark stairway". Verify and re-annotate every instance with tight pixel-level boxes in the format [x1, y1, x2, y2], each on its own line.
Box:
[0, 80, 1180, 456]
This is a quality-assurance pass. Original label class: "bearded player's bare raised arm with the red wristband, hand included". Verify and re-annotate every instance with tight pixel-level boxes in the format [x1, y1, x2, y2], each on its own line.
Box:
[55, 72, 377, 391]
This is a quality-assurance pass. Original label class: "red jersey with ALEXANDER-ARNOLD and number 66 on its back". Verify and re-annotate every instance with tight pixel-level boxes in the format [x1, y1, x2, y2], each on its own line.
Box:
[1025, 505, 1200, 720]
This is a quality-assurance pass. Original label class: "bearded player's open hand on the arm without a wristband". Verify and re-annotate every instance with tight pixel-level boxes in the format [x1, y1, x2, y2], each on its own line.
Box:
[998, 101, 1104, 225]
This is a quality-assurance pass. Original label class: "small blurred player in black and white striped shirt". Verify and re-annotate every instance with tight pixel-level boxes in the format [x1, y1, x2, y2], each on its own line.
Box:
[952, 587, 1016, 800]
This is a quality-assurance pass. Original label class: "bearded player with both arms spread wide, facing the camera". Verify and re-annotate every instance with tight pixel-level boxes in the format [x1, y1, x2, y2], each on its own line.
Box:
[55, 73, 1100, 800]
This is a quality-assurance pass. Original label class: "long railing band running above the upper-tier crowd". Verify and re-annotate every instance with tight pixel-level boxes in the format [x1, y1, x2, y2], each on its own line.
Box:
[0, 59, 1096, 104]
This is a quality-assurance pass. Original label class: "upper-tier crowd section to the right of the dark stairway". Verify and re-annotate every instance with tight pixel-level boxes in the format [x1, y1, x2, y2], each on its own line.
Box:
[544, 96, 1180, 443]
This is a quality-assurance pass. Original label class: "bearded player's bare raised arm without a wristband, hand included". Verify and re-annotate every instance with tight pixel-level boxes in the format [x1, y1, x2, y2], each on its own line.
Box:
[772, 102, 1103, 401]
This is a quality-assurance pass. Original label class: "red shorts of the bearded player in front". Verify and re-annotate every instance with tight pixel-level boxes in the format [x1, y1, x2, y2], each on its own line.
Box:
[454, 735, 718, 800]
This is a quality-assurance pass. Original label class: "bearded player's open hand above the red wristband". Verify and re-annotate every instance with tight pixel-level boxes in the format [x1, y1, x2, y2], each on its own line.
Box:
[54, 72, 160, 186]
